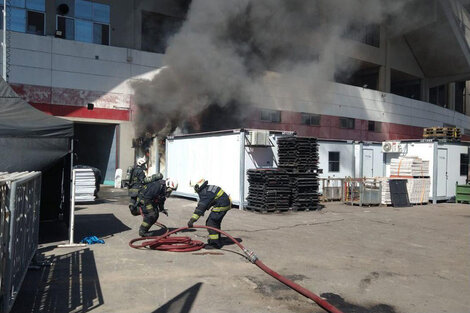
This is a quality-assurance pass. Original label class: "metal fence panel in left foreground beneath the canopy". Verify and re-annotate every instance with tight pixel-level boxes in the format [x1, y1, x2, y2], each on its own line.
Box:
[0, 172, 41, 313]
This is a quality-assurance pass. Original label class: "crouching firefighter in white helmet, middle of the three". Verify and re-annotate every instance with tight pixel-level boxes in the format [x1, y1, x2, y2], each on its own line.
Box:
[137, 179, 178, 237]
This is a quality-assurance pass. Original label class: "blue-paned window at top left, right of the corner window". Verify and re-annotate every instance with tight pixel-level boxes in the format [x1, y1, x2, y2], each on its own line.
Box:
[57, 0, 110, 45]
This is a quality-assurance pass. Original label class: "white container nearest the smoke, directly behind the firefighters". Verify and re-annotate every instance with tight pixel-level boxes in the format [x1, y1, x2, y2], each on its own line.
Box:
[165, 130, 288, 208]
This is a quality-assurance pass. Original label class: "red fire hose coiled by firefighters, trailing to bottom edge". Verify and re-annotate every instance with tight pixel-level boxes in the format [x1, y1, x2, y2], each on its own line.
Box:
[129, 223, 343, 313]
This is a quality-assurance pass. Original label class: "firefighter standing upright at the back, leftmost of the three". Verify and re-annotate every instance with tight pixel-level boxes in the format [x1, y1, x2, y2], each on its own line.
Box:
[126, 157, 163, 216]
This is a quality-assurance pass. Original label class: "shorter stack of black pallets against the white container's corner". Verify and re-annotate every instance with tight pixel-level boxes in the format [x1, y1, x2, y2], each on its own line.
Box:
[247, 169, 291, 213]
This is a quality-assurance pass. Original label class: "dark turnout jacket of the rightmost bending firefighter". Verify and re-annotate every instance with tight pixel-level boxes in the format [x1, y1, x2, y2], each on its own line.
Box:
[191, 185, 232, 220]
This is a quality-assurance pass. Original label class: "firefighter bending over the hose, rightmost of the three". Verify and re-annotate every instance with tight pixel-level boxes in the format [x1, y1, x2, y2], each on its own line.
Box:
[188, 179, 232, 249]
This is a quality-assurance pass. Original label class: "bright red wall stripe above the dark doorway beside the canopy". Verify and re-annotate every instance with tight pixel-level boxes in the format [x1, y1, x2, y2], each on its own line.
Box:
[30, 103, 129, 121]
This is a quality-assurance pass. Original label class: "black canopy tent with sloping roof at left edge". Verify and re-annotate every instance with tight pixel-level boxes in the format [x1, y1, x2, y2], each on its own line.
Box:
[0, 78, 73, 219]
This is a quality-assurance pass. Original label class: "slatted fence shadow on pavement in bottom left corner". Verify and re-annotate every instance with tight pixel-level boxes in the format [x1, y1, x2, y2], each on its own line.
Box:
[11, 249, 104, 313]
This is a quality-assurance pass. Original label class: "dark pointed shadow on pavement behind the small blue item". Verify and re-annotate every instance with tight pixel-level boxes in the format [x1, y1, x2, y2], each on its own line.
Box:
[74, 214, 131, 241]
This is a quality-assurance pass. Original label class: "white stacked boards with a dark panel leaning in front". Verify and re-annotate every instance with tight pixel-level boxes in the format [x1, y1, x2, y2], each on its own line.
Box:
[382, 157, 431, 205]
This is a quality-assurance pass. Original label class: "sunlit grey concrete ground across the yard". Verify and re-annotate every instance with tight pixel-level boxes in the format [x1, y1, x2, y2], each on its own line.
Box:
[12, 188, 470, 313]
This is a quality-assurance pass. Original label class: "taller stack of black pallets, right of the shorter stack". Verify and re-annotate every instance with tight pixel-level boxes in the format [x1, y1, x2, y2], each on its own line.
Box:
[278, 136, 319, 211]
